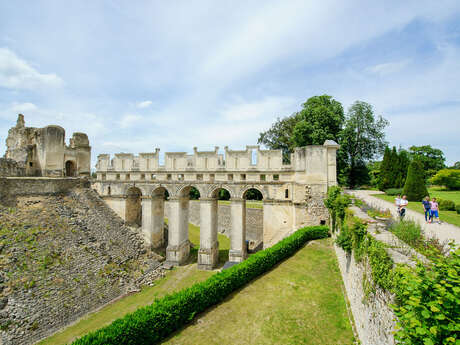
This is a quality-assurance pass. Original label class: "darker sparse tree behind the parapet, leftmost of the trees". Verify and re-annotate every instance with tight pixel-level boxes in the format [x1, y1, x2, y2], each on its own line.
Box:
[257, 113, 300, 163]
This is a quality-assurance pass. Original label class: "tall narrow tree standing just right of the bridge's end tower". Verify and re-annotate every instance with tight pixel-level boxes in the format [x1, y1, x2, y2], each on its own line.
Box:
[339, 101, 388, 188]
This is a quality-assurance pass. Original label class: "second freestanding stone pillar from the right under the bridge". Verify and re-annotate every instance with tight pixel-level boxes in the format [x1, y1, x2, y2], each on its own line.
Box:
[198, 198, 219, 270]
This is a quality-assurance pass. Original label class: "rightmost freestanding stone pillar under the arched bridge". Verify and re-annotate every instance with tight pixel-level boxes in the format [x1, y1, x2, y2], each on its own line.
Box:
[228, 198, 247, 262]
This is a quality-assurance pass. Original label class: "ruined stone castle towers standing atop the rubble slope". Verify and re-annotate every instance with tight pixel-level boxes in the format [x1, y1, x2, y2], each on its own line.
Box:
[5, 114, 91, 177]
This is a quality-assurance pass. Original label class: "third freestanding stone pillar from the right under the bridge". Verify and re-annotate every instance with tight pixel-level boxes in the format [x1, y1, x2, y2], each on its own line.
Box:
[166, 197, 190, 266]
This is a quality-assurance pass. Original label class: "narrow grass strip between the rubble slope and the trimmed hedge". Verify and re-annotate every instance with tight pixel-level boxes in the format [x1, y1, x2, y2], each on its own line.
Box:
[39, 224, 230, 345]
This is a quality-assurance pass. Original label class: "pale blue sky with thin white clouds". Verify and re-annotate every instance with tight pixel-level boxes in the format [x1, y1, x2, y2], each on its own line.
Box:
[0, 0, 460, 164]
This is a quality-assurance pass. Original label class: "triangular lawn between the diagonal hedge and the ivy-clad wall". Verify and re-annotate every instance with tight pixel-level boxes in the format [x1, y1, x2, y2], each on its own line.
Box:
[164, 239, 354, 345]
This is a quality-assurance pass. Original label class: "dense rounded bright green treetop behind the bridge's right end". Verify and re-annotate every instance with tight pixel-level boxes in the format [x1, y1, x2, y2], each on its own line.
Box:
[292, 95, 345, 147]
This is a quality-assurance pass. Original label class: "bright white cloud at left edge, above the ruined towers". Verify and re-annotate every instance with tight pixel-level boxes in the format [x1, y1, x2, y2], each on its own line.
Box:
[0, 48, 63, 90]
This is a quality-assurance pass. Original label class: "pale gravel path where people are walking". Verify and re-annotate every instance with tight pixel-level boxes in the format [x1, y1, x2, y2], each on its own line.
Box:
[345, 190, 460, 244]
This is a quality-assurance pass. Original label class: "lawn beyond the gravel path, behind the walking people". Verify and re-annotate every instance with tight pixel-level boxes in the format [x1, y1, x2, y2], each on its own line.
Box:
[373, 187, 460, 227]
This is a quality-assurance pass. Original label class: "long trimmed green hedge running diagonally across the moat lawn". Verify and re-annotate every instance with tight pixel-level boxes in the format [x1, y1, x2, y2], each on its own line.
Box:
[73, 226, 329, 345]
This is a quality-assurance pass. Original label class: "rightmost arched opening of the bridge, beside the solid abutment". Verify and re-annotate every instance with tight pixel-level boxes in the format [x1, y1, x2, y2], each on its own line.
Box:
[243, 188, 264, 253]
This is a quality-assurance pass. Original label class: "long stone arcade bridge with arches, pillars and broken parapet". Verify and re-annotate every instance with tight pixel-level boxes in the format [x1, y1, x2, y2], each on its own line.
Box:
[93, 140, 339, 269]
